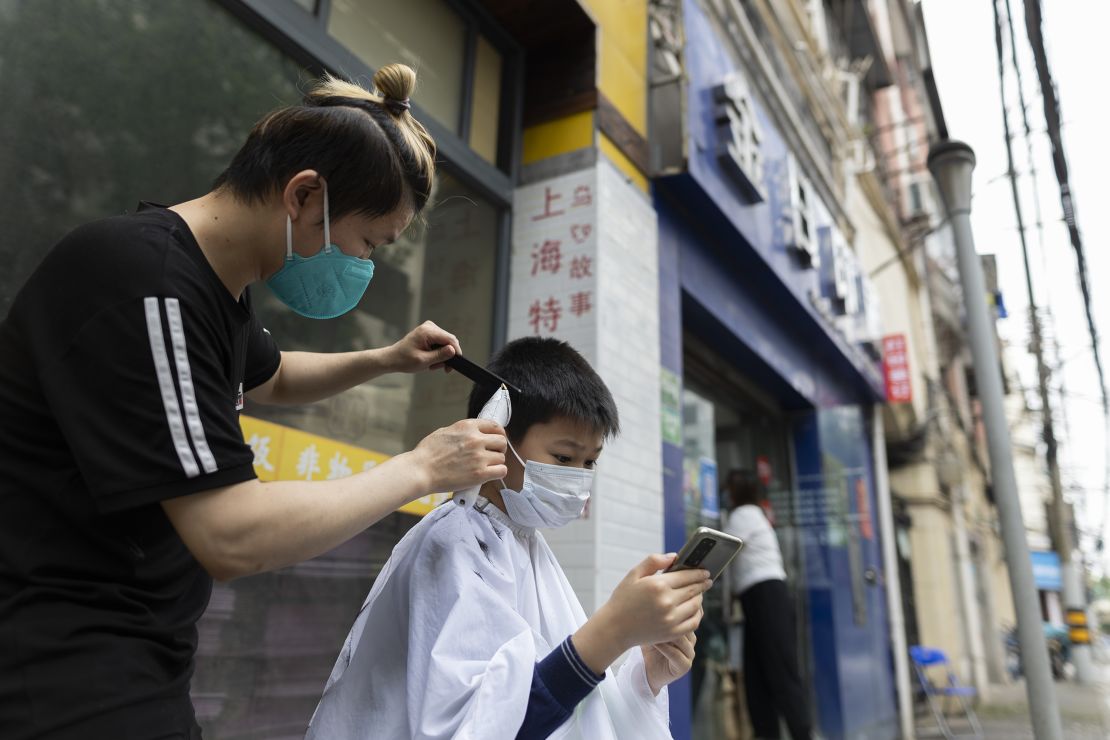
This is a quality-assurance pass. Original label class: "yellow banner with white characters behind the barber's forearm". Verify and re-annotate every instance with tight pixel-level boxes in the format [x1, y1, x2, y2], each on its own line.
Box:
[239, 416, 451, 516]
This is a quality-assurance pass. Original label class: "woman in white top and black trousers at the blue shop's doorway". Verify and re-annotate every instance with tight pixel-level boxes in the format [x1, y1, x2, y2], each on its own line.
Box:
[725, 470, 813, 740]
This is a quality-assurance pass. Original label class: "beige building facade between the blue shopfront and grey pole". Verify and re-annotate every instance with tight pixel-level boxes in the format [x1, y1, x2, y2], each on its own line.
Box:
[870, 0, 1013, 696]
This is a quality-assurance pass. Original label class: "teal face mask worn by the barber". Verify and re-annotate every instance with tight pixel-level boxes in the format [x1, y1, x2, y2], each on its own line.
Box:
[266, 185, 374, 318]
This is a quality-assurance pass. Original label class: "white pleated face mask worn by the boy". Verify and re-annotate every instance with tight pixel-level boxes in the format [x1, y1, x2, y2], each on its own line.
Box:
[501, 444, 594, 528]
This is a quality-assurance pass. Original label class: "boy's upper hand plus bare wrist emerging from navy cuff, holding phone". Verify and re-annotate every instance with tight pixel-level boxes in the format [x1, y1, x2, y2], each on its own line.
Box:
[574, 554, 713, 673]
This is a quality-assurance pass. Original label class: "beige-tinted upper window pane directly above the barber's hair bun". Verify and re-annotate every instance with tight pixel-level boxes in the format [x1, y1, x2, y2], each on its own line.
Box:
[327, 0, 466, 131]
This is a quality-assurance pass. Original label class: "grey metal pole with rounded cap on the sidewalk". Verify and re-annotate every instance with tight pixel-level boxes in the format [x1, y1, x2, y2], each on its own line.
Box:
[928, 140, 1063, 740]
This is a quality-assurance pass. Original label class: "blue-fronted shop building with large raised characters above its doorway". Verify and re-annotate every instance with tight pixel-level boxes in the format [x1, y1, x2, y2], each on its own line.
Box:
[650, 0, 902, 738]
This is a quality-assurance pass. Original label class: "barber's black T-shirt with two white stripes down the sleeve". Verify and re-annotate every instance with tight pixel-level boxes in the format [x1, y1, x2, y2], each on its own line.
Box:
[0, 204, 280, 740]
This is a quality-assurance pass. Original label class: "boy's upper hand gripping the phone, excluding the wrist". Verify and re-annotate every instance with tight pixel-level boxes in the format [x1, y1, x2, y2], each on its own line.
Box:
[598, 555, 713, 650]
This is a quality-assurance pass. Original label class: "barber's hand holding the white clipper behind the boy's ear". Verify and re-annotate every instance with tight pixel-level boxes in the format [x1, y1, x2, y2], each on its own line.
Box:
[412, 419, 508, 493]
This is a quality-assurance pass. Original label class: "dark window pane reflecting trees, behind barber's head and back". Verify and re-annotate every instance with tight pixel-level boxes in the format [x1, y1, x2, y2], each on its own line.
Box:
[0, 0, 307, 317]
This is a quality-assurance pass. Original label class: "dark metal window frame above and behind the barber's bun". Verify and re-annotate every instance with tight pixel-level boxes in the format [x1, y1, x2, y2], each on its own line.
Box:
[218, 0, 524, 349]
